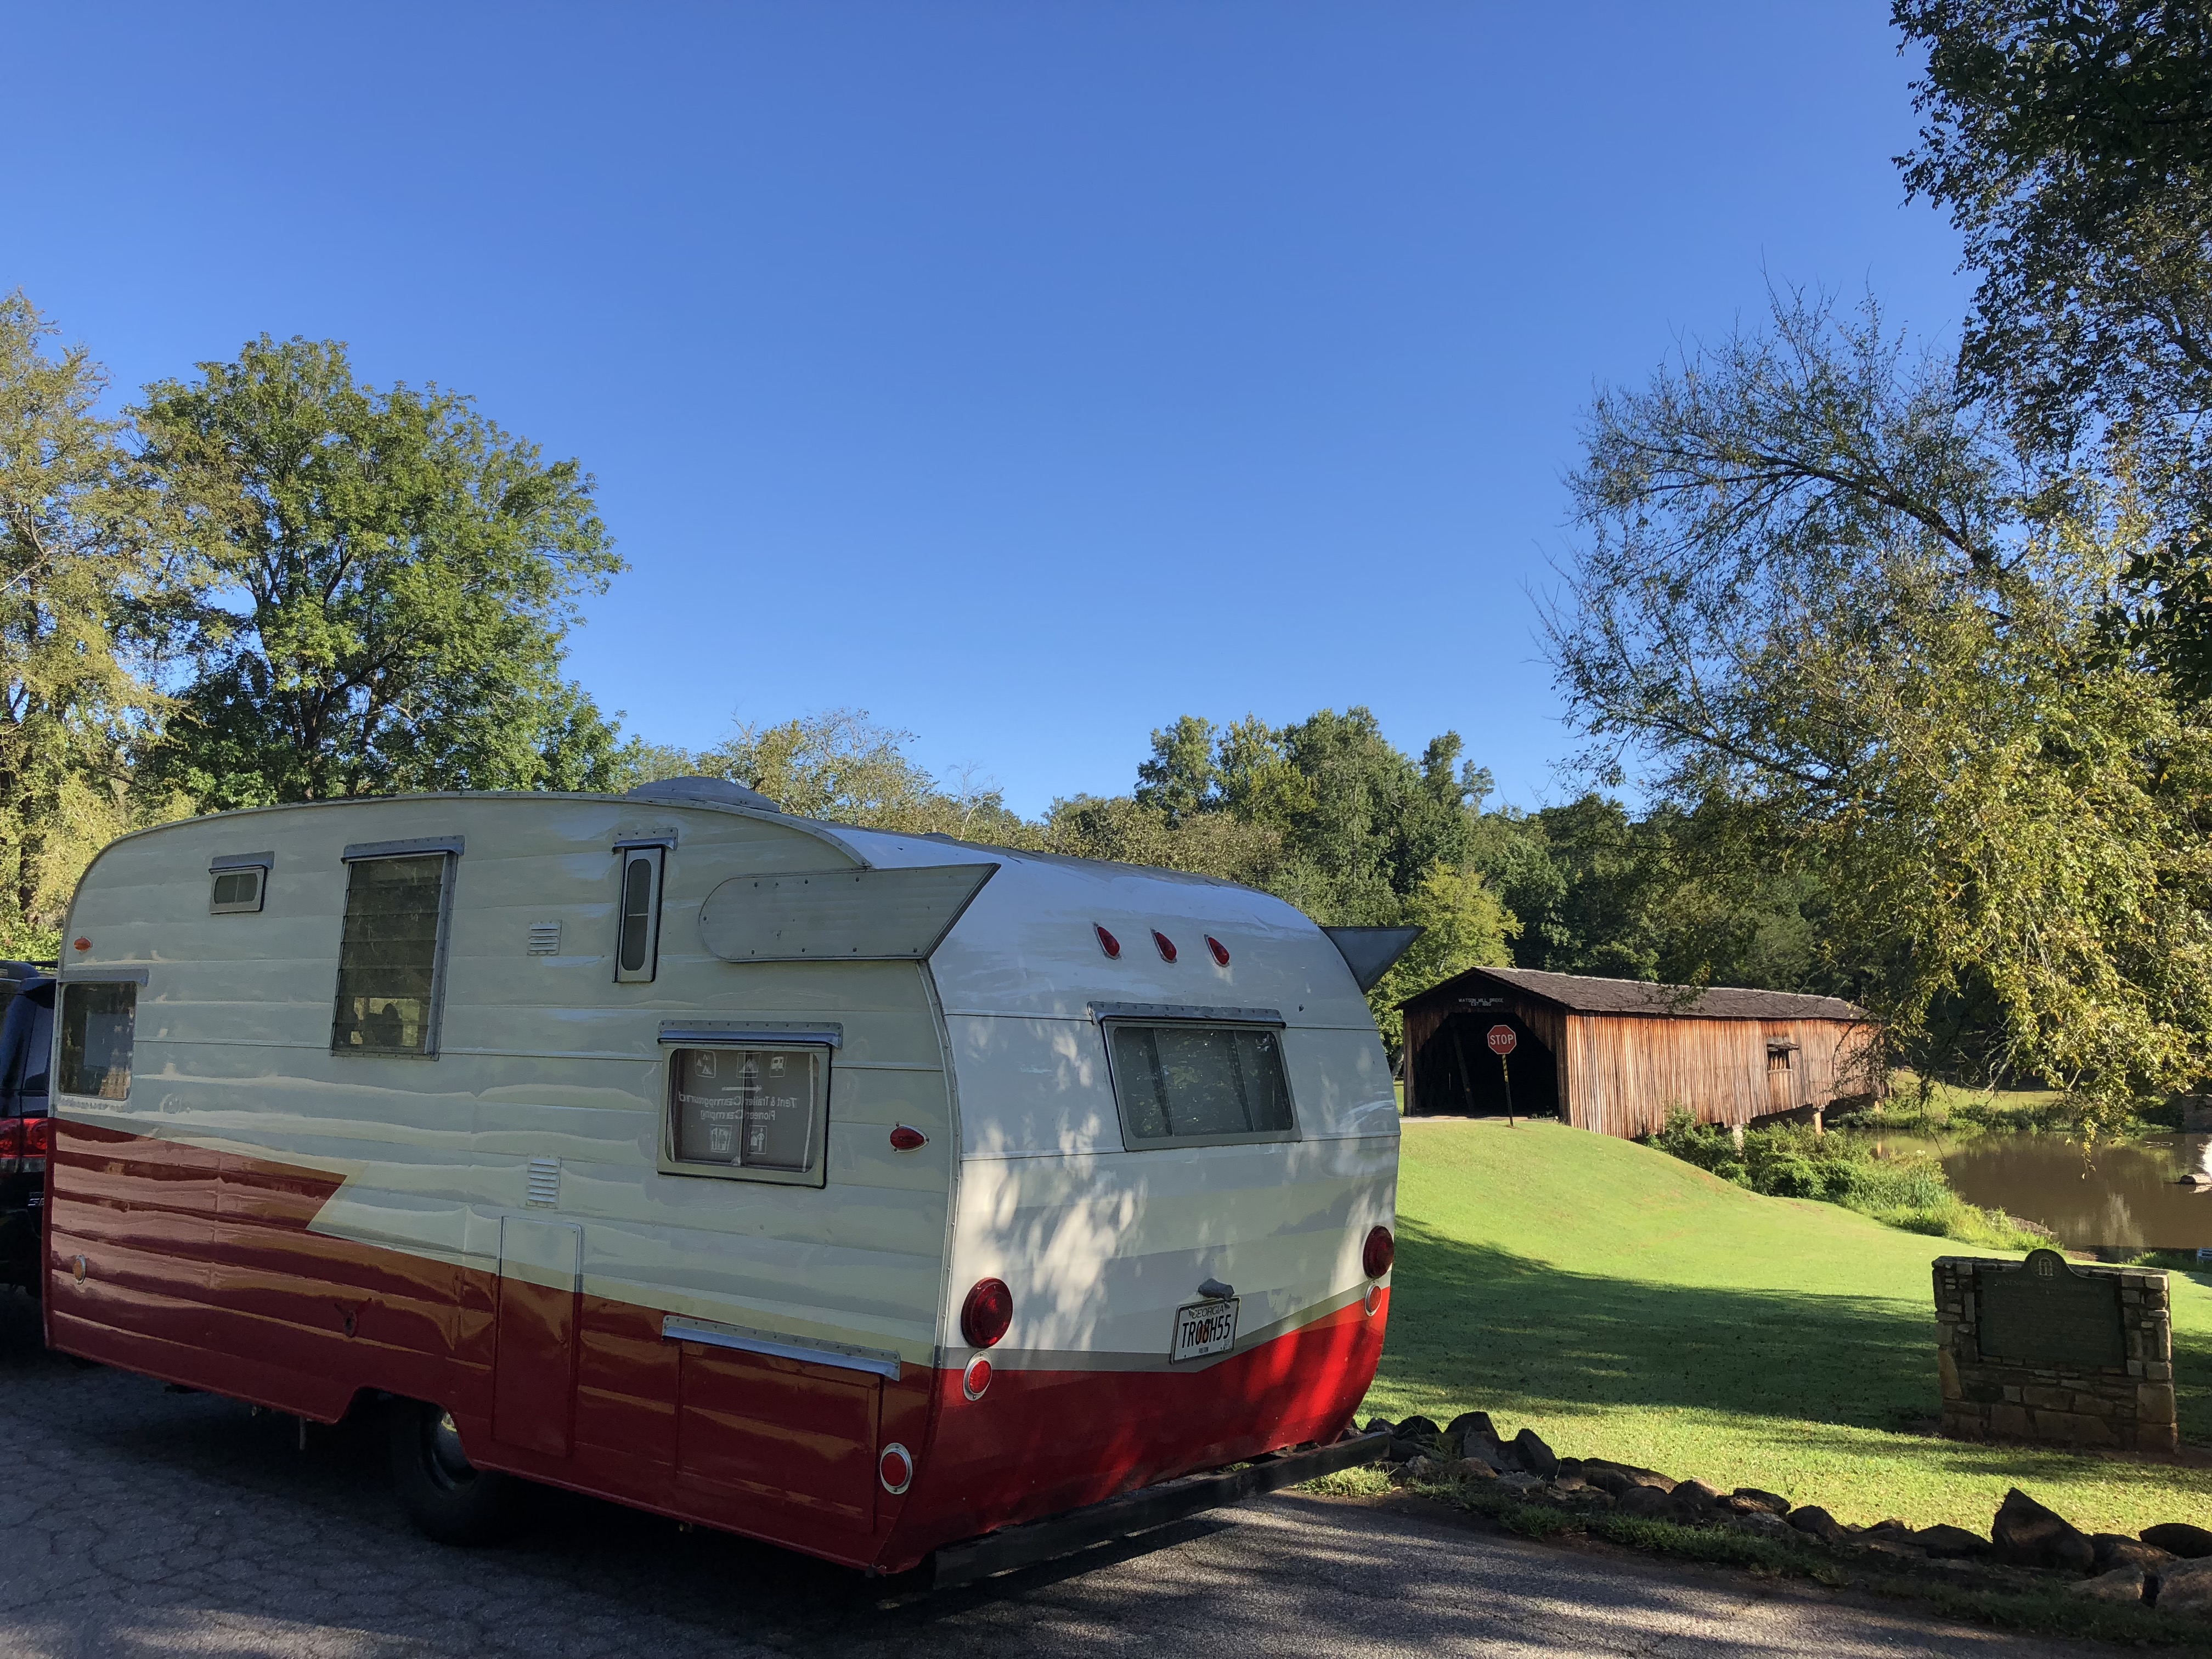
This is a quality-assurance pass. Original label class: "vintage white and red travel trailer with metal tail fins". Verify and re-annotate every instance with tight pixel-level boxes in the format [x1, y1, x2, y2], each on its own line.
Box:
[44, 778, 1398, 1573]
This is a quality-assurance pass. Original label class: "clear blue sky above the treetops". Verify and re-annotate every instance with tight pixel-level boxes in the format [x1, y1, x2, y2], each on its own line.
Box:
[0, 0, 1968, 814]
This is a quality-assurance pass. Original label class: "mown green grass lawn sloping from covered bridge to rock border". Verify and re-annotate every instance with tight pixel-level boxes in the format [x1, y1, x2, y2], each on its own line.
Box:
[1363, 1121, 2212, 1533]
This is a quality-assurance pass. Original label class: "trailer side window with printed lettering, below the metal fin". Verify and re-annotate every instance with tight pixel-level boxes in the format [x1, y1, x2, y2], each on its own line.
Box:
[668, 1046, 830, 1179]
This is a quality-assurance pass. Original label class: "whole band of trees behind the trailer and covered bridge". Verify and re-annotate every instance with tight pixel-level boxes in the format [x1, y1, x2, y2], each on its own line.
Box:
[13, 0, 2212, 1121]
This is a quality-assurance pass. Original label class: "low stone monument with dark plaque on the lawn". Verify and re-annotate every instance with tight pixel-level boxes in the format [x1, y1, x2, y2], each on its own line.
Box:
[1936, 1250, 2179, 1451]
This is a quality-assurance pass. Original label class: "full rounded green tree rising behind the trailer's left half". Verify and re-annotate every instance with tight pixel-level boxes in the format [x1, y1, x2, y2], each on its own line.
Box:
[137, 336, 622, 808]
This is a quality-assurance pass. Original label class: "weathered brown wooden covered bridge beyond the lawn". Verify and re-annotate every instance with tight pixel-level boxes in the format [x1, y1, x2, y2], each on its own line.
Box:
[1400, 969, 1884, 1137]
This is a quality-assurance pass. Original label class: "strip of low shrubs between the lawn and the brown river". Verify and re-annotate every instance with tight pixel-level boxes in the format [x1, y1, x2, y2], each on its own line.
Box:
[1650, 1110, 2051, 1250]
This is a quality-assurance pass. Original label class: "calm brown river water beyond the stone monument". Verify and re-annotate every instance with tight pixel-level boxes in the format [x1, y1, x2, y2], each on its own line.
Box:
[1878, 1135, 2212, 1250]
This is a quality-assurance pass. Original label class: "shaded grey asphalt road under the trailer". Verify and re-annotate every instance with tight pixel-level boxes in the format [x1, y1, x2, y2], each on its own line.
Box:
[0, 1296, 2123, 1659]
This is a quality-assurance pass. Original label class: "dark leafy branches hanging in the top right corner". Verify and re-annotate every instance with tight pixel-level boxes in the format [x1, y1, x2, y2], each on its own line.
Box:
[1893, 0, 2212, 695]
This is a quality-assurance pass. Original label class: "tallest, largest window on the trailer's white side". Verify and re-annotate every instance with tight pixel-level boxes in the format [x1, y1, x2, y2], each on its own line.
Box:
[330, 849, 454, 1055]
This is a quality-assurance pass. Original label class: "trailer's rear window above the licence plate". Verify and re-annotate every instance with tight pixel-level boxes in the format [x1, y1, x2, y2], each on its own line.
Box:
[1106, 1020, 1296, 1146]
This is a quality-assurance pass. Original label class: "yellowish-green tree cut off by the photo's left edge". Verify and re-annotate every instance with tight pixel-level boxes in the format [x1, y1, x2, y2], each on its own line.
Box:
[0, 292, 199, 956]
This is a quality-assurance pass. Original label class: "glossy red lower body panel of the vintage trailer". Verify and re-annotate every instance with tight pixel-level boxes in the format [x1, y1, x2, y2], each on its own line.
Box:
[47, 1119, 1389, 1571]
